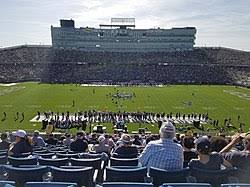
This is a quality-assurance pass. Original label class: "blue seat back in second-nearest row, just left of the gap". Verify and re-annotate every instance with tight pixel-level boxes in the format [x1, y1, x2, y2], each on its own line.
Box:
[51, 167, 95, 187]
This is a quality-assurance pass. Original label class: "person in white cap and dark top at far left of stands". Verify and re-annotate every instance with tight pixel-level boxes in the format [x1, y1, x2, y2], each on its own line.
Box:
[9, 130, 32, 156]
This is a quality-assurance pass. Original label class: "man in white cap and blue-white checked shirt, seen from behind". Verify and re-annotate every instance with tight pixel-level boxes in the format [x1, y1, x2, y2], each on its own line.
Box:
[139, 122, 184, 171]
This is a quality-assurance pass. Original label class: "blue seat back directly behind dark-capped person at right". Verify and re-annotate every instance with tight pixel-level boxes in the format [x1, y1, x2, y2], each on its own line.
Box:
[191, 168, 237, 186]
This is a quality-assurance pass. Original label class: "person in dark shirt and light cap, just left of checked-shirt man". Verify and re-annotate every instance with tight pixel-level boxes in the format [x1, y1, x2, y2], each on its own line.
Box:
[112, 134, 138, 158]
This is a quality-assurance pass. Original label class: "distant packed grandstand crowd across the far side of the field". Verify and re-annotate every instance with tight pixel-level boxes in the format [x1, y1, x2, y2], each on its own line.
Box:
[0, 46, 250, 86]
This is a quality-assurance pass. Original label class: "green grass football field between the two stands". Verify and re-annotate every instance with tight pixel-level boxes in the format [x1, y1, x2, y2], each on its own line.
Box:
[0, 82, 250, 133]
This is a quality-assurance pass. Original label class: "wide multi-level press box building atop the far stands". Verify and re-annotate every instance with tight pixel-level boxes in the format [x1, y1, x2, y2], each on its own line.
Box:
[51, 18, 196, 52]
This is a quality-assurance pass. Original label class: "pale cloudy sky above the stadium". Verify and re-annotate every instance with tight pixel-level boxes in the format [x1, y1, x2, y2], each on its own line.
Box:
[0, 0, 250, 51]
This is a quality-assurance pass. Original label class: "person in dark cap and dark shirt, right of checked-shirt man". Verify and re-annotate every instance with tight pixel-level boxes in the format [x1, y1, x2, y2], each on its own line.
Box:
[189, 136, 231, 170]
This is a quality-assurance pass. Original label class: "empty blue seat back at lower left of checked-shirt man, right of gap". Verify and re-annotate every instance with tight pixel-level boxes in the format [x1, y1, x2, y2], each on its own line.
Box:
[106, 167, 147, 182]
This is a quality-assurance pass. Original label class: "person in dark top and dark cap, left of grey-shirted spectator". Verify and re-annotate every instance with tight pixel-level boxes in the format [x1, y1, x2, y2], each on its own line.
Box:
[70, 131, 88, 152]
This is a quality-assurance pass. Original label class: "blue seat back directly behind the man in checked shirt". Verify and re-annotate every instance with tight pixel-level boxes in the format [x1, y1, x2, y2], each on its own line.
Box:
[149, 167, 190, 186]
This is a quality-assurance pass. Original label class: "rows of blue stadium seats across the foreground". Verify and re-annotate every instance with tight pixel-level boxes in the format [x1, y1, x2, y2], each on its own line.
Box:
[0, 146, 250, 187]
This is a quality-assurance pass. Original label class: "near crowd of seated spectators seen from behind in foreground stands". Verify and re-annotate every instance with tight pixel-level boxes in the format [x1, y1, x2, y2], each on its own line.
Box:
[0, 121, 250, 186]
